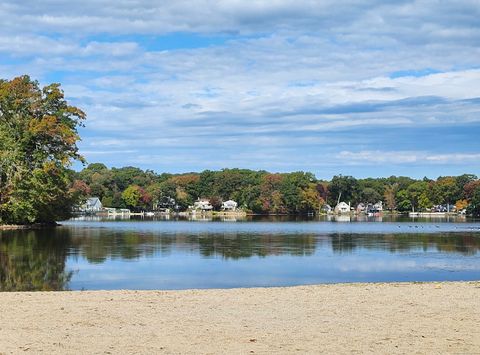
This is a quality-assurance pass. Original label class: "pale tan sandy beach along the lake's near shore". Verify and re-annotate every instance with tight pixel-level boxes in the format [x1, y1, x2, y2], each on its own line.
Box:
[0, 282, 480, 354]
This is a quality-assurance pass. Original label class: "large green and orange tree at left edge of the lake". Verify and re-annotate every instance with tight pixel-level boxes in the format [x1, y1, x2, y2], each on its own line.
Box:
[0, 76, 85, 224]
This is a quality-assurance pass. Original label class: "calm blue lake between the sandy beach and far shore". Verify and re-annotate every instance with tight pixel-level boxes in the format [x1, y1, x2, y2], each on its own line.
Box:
[0, 218, 480, 291]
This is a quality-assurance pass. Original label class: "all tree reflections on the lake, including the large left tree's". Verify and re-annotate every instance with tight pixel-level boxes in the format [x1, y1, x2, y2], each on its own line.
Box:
[0, 224, 480, 291]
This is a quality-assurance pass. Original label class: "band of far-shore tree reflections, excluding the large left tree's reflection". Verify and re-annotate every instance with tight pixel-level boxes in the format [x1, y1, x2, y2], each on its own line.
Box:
[64, 229, 480, 263]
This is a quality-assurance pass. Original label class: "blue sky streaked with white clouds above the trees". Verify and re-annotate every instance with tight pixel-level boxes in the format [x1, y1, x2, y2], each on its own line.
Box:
[0, 0, 480, 179]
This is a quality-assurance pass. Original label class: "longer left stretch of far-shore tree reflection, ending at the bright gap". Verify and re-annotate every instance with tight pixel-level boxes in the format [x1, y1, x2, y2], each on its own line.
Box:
[65, 229, 316, 263]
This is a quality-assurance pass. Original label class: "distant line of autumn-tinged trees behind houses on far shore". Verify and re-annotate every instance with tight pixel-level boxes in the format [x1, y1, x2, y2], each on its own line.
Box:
[73, 163, 480, 214]
